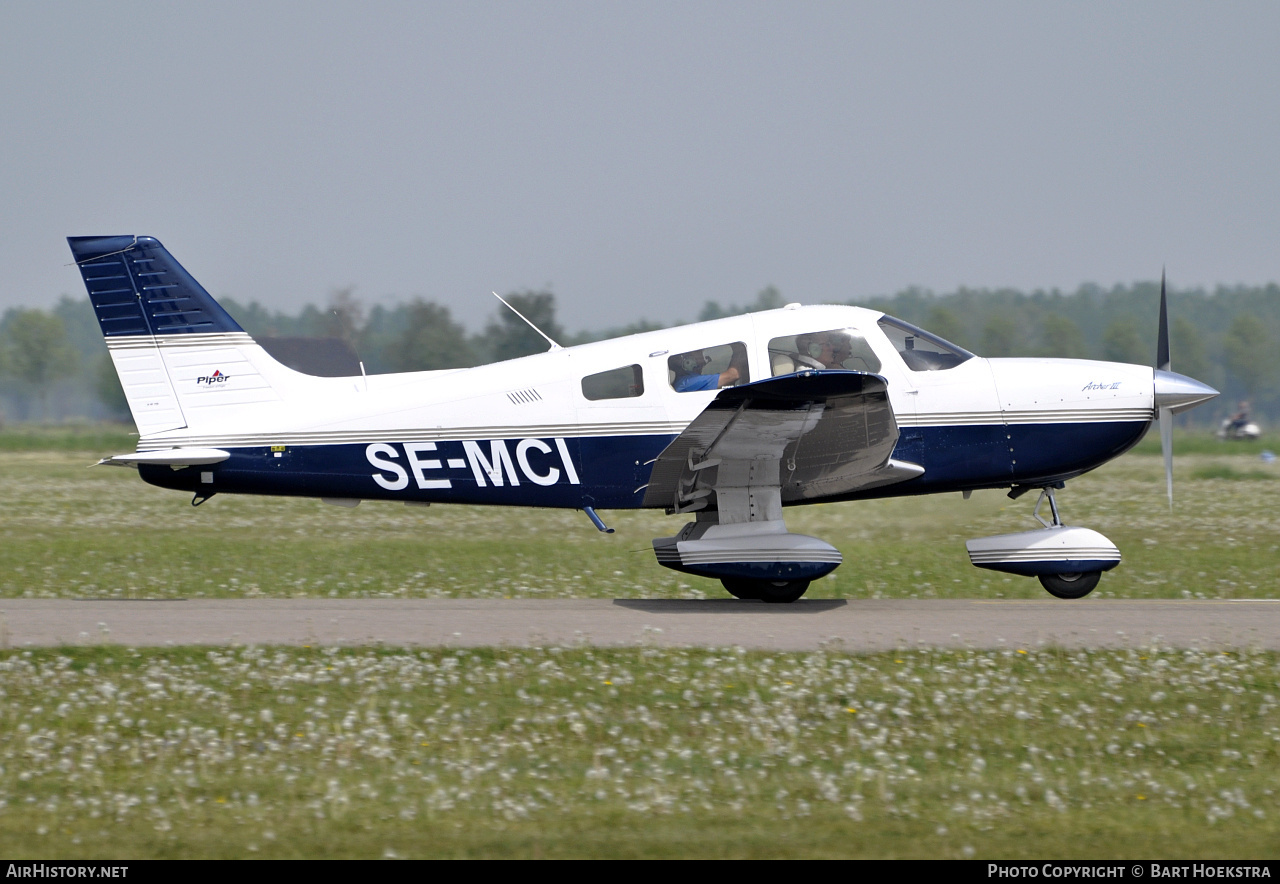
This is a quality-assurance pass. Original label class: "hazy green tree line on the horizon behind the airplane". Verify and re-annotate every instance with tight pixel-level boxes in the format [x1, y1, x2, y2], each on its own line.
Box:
[0, 283, 1280, 423]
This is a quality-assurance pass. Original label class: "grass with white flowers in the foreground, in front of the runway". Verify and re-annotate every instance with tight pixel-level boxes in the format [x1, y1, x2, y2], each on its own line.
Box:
[0, 647, 1280, 858]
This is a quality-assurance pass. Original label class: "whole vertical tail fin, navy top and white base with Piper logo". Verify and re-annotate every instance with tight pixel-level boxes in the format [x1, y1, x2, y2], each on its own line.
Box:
[67, 237, 299, 438]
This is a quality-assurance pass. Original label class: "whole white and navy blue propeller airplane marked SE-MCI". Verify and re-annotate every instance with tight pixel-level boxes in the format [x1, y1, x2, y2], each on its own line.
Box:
[68, 235, 1217, 603]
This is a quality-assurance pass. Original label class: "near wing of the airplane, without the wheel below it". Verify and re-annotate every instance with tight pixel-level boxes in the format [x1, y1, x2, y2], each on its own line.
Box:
[644, 371, 924, 511]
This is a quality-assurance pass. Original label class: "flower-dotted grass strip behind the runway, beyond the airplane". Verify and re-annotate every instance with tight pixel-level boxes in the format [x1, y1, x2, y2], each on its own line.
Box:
[0, 434, 1280, 599]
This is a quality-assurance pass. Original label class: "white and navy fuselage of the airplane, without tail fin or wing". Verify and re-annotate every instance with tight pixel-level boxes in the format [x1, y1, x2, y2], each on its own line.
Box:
[135, 306, 1155, 509]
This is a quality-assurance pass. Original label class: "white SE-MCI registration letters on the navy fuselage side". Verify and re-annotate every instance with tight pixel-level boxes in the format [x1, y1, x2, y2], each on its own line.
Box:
[365, 439, 582, 491]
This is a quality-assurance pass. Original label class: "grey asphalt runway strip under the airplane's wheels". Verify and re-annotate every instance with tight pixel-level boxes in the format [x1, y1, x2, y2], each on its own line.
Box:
[0, 599, 1280, 651]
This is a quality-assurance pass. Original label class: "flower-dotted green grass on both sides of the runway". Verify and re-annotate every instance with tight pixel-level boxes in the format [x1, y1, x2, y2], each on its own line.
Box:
[0, 427, 1280, 858]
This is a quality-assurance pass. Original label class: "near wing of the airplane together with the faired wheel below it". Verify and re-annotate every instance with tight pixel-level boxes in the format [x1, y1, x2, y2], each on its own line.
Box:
[644, 371, 924, 601]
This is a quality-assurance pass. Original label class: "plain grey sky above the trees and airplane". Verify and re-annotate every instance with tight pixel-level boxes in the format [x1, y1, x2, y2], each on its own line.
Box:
[0, 0, 1280, 329]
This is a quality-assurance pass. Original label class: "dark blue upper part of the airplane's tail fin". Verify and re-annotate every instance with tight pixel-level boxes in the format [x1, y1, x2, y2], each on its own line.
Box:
[67, 237, 243, 338]
